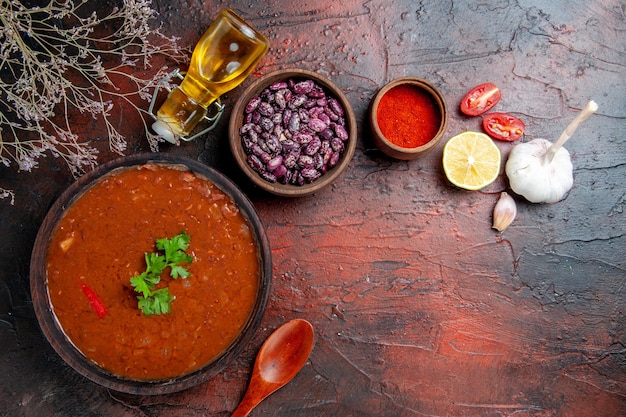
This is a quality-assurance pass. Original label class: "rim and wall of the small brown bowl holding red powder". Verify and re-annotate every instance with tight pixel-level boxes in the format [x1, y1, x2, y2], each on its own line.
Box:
[369, 77, 448, 159]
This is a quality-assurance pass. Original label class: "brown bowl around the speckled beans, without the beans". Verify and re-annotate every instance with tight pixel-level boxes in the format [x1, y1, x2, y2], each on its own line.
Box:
[228, 69, 357, 197]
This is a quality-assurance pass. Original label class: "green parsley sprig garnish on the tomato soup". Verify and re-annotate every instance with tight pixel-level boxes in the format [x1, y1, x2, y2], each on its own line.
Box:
[130, 231, 192, 315]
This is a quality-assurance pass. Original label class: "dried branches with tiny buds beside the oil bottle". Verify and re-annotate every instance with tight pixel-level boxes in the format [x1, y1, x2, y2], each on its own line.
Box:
[0, 0, 189, 201]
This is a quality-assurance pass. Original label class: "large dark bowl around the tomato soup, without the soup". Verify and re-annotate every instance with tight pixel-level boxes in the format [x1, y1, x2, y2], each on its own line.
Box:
[30, 154, 272, 395]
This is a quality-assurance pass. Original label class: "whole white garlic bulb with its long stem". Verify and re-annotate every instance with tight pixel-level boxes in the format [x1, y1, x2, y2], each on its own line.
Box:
[505, 101, 598, 203]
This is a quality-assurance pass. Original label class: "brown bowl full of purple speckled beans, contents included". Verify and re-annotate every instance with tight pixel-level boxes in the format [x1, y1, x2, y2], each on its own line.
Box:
[228, 69, 356, 197]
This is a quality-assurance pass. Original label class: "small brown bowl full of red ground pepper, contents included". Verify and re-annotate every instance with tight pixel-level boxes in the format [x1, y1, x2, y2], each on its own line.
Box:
[369, 77, 448, 160]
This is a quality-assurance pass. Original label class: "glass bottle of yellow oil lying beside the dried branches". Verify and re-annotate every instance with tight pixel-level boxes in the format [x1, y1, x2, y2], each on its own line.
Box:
[153, 9, 269, 142]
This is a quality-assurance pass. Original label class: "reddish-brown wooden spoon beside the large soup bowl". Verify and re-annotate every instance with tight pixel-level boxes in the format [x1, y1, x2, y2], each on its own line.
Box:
[232, 319, 315, 417]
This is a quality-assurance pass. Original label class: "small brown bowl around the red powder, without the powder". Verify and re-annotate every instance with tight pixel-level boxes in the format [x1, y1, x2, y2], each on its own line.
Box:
[368, 77, 448, 160]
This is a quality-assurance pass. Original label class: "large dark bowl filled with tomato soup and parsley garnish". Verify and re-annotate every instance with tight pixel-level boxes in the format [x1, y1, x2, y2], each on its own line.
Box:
[30, 154, 272, 395]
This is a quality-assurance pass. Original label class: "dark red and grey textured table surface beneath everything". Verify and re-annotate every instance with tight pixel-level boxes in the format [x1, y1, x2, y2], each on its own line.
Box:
[0, 0, 626, 417]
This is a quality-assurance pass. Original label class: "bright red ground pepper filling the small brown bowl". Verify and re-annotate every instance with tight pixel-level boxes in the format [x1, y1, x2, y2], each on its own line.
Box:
[376, 84, 441, 148]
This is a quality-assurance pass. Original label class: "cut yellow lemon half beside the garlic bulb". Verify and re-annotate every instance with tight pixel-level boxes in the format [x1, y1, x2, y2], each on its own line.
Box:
[443, 131, 501, 190]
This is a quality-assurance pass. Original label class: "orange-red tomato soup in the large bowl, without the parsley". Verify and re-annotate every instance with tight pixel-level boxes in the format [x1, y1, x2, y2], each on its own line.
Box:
[46, 164, 260, 380]
